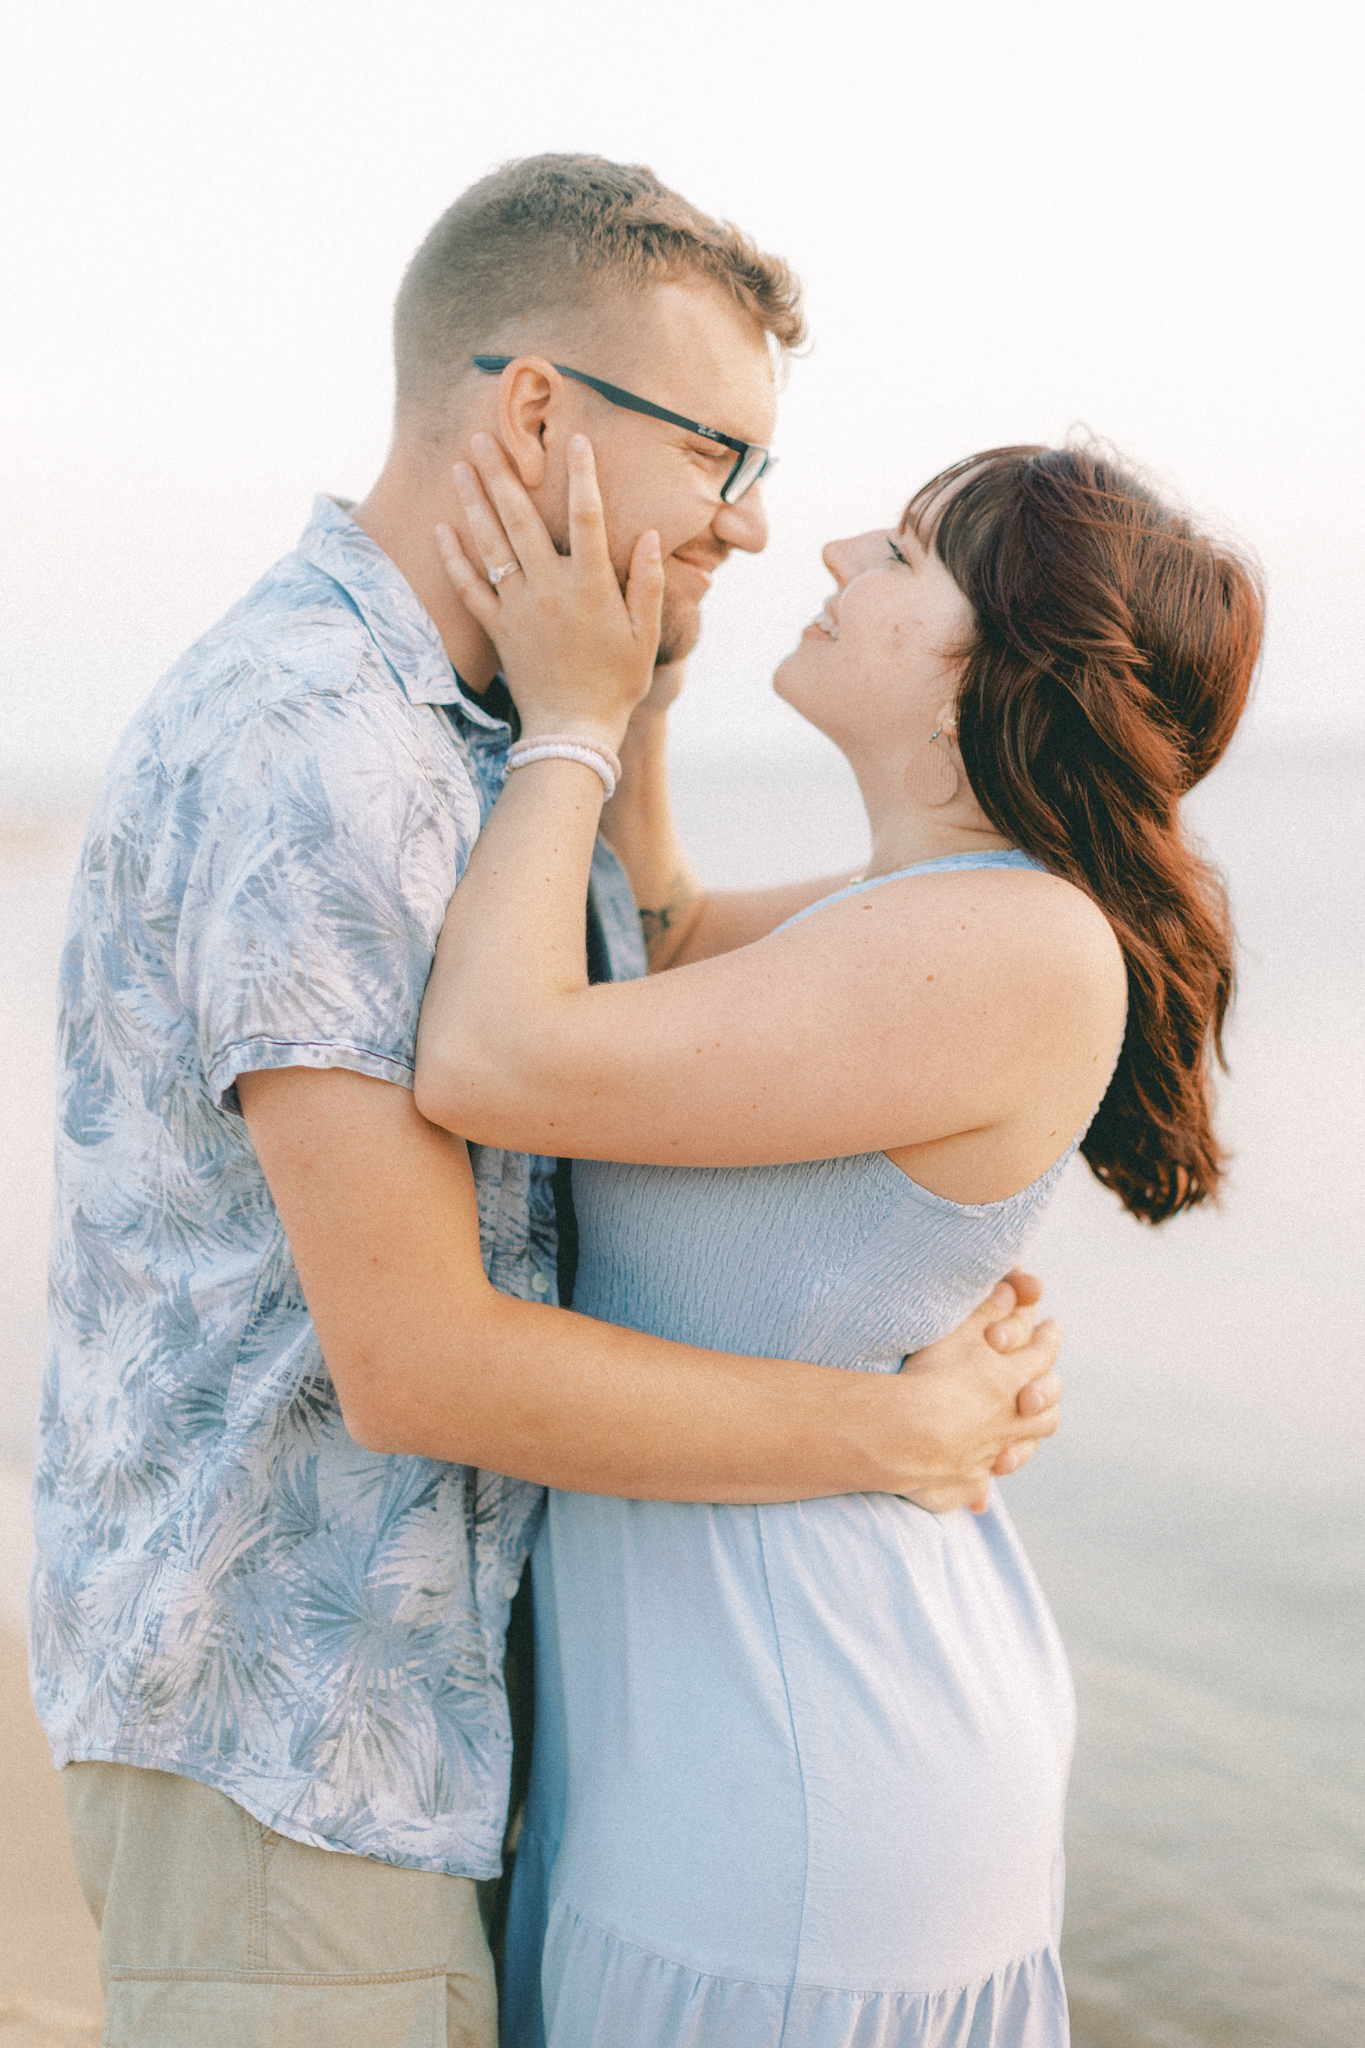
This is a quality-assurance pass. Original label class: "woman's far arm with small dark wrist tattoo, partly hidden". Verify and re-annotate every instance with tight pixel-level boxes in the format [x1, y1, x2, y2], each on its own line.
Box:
[600, 666, 849, 975]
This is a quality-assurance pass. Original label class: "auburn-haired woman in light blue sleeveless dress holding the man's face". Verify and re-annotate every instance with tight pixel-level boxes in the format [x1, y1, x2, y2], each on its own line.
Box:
[417, 428, 1261, 2048]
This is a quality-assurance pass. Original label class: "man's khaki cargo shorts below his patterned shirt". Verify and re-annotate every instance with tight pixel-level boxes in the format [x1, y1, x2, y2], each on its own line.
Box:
[61, 1763, 497, 2048]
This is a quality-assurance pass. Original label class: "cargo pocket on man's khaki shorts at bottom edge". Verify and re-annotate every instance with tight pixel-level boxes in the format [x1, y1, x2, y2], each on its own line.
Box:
[102, 1966, 448, 2048]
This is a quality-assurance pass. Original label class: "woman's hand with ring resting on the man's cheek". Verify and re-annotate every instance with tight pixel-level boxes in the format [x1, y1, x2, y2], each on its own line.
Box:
[436, 434, 663, 748]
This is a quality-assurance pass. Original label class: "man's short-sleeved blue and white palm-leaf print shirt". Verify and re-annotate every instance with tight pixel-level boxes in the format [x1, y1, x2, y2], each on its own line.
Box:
[31, 498, 645, 1878]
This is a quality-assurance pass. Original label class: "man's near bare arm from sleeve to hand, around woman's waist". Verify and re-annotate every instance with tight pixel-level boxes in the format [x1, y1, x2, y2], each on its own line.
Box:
[237, 1067, 1056, 1505]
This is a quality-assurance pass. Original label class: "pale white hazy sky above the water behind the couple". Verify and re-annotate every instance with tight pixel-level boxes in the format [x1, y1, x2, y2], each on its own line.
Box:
[0, 0, 1365, 799]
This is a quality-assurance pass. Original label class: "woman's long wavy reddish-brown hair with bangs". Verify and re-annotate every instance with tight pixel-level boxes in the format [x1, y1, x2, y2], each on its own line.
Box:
[905, 446, 1265, 1223]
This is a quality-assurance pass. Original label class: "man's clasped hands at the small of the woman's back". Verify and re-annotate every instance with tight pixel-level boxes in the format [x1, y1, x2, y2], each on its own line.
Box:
[900, 1272, 1062, 1513]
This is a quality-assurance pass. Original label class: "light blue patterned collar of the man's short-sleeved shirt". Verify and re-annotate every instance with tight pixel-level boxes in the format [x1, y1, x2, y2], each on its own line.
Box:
[299, 498, 508, 739]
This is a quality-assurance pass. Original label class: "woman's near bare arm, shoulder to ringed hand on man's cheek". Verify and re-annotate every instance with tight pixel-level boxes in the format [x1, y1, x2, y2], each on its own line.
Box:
[429, 442, 1124, 1200]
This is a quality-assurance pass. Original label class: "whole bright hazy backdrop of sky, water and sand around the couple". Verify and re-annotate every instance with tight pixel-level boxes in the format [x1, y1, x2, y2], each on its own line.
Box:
[0, 12, 1365, 2048]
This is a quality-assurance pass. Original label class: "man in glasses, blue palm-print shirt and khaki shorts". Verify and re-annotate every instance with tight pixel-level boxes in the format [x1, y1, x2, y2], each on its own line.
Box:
[33, 158, 1056, 2048]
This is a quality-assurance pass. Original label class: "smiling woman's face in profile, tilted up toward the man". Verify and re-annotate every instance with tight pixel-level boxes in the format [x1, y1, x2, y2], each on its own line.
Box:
[774, 526, 974, 754]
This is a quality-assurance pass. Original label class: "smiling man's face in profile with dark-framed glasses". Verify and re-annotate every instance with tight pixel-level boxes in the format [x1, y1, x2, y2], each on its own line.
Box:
[536, 283, 778, 662]
